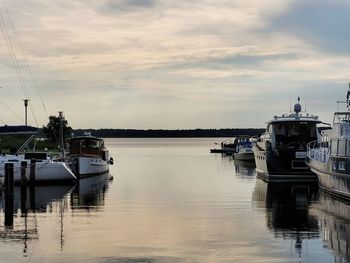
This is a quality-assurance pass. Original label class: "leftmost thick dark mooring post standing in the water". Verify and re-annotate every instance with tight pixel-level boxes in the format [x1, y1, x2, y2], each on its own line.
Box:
[5, 163, 14, 226]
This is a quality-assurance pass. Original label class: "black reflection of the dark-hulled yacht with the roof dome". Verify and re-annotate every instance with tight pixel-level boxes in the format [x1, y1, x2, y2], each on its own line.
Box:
[253, 179, 319, 257]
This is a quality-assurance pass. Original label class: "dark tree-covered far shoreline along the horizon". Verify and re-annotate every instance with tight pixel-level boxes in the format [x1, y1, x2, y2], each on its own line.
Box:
[73, 128, 265, 138]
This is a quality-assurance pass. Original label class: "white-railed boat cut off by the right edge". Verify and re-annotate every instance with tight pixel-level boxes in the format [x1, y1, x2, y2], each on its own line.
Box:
[307, 85, 350, 199]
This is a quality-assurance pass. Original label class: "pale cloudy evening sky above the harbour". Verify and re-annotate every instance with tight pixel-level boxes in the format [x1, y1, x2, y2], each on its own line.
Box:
[0, 0, 350, 129]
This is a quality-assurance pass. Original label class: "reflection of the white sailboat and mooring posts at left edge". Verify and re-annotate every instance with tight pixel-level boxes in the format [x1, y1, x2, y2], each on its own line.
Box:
[0, 186, 73, 256]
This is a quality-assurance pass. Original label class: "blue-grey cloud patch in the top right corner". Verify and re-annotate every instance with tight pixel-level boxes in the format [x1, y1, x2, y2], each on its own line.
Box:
[267, 0, 350, 54]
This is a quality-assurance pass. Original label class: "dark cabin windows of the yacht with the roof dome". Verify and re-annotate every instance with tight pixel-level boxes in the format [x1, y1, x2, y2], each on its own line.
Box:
[273, 121, 317, 150]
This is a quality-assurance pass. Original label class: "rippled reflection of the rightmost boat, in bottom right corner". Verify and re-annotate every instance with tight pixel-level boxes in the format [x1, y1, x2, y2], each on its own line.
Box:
[310, 192, 350, 262]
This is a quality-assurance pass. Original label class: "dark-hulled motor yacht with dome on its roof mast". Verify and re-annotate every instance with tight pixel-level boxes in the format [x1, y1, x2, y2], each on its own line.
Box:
[253, 98, 321, 182]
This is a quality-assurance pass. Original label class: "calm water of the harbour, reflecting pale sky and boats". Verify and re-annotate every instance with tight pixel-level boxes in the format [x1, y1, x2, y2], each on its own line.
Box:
[0, 138, 350, 263]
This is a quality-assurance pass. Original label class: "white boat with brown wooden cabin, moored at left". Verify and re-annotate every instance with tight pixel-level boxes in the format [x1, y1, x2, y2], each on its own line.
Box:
[68, 133, 113, 179]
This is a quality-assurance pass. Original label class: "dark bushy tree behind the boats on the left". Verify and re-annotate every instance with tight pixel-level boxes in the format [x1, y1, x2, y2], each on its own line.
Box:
[43, 116, 73, 144]
